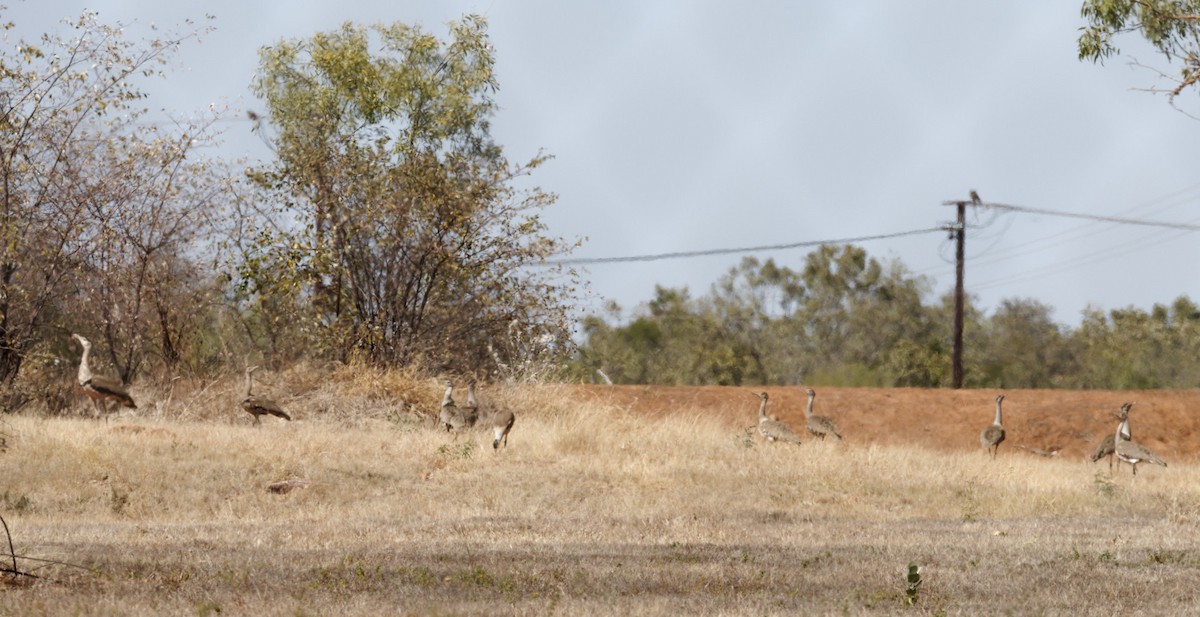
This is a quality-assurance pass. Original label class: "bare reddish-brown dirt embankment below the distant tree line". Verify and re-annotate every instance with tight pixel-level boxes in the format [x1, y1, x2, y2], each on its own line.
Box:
[571, 385, 1200, 461]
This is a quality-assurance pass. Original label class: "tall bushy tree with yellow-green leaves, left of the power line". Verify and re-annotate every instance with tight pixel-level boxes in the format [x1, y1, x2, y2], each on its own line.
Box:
[241, 16, 574, 369]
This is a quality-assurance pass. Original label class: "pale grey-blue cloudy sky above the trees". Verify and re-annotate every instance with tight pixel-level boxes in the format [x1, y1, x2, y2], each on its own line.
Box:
[4, 0, 1200, 325]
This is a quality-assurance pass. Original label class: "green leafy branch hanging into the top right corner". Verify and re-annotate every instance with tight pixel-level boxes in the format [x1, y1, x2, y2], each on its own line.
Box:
[1078, 0, 1200, 106]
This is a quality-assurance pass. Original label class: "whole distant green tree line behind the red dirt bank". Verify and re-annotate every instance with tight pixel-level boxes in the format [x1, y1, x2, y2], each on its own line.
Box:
[570, 245, 1200, 390]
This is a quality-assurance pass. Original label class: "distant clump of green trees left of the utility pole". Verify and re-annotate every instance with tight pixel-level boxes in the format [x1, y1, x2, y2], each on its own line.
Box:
[575, 246, 949, 385]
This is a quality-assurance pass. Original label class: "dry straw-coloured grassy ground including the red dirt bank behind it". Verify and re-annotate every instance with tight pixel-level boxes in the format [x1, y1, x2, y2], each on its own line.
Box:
[0, 370, 1200, 616]
